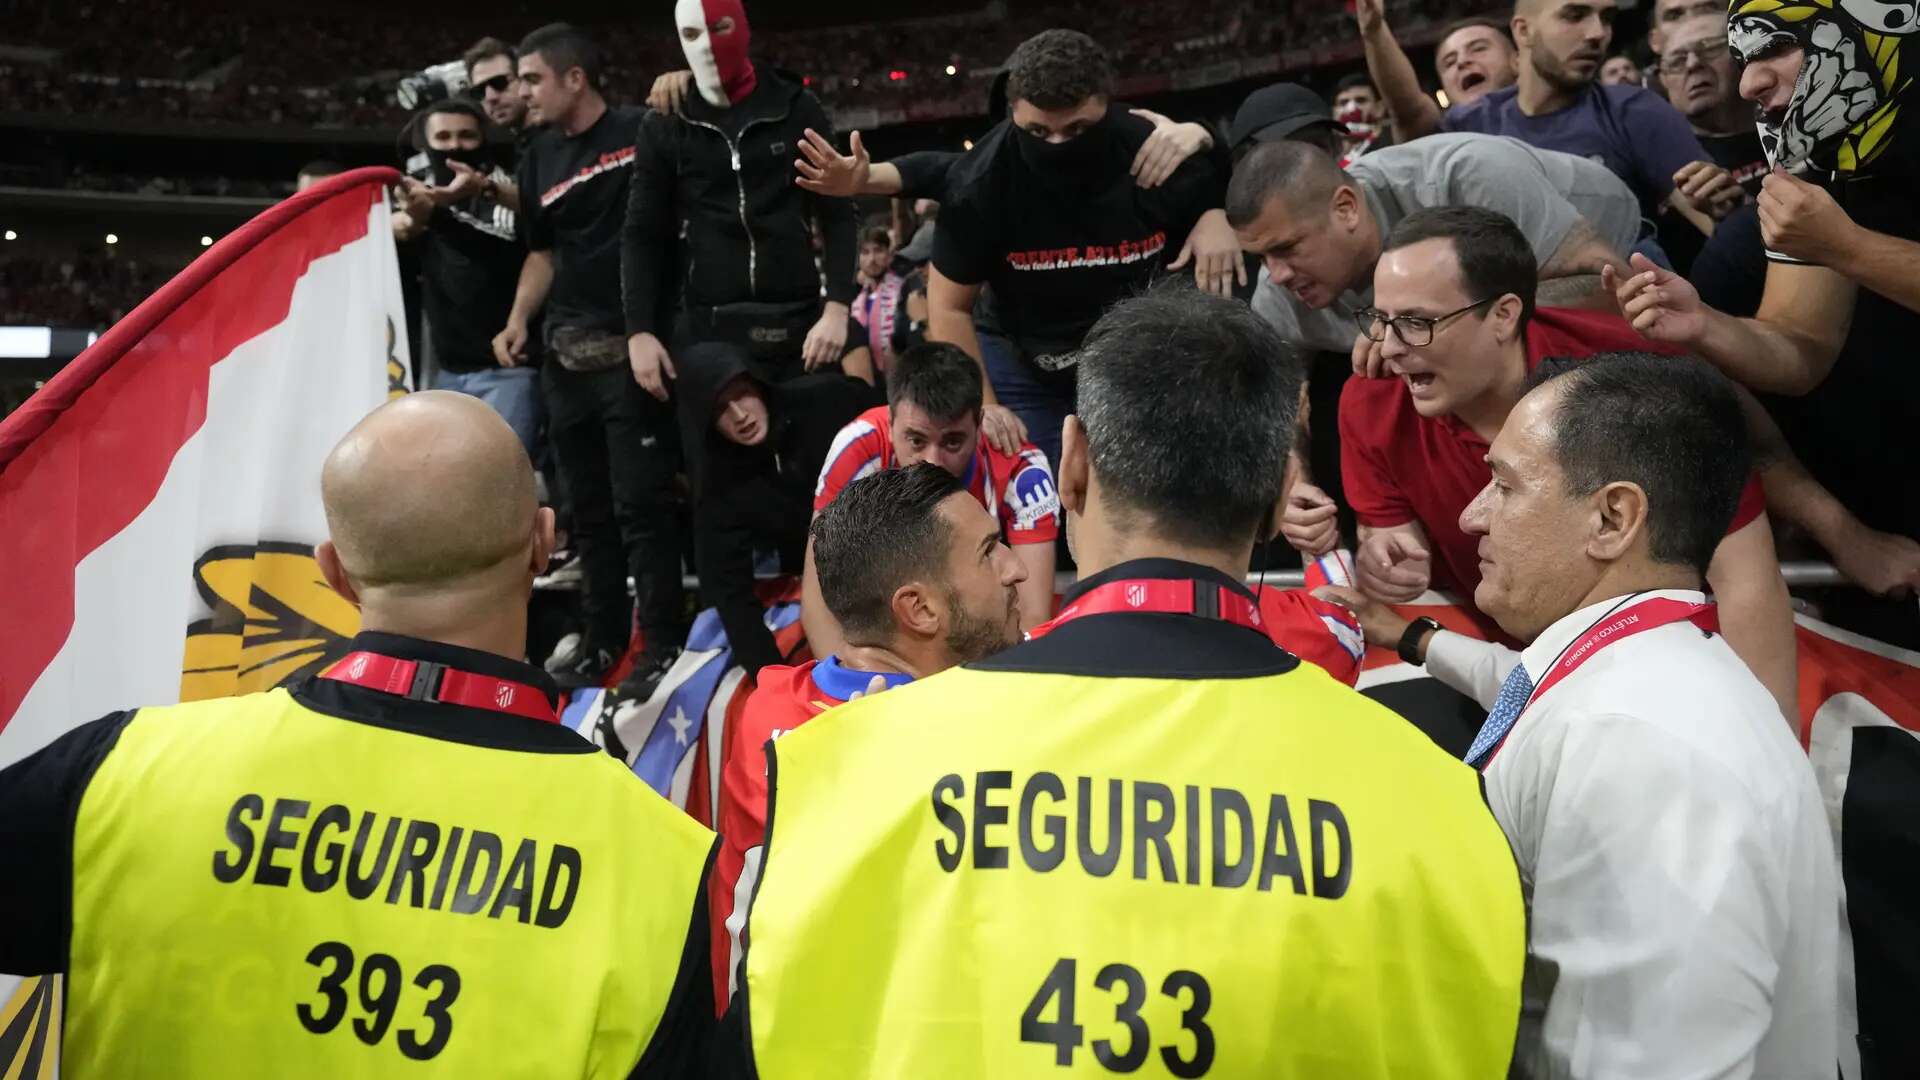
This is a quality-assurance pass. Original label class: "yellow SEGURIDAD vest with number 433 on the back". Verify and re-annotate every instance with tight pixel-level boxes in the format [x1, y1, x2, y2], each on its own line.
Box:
[745, 665, 1526, 1080]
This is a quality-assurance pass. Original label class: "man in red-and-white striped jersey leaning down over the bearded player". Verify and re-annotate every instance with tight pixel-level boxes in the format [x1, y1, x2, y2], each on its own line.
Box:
[801, 342, 1060, 655]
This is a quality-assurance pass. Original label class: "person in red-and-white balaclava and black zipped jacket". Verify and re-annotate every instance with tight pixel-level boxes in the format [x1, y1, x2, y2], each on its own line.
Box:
[620, 0, 858, 402]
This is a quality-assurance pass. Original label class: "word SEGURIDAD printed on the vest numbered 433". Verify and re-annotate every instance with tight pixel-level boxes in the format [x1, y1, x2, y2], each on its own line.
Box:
[931, 769, 1354, 899]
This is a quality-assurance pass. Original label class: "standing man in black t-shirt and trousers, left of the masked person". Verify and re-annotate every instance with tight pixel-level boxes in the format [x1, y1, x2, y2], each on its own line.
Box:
[493, 23, 685, 698]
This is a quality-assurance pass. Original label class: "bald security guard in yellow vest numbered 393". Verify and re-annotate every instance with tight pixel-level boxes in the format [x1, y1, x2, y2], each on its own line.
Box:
[0, 392, 714, 1078]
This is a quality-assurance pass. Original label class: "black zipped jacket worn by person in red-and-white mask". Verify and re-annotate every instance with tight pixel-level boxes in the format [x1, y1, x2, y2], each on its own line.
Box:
[620, 63, 860, 338]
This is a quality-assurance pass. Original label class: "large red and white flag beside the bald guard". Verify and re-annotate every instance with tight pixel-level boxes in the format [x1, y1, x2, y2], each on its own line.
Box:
[0, 169, 409, 1076]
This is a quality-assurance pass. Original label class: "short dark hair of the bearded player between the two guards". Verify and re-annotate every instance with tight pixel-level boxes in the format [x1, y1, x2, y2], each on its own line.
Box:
[812, 461, 966, 646]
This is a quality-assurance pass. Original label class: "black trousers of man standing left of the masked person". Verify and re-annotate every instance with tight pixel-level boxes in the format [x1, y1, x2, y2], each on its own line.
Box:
[541, 359, 687, 653]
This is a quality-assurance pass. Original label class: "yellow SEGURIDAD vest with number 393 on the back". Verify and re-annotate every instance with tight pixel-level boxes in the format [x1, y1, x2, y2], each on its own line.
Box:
[63, 690, 712, 1078]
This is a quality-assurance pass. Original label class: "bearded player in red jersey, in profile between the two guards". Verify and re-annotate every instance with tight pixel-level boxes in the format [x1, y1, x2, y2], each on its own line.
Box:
[707, 463, 1036, 1013]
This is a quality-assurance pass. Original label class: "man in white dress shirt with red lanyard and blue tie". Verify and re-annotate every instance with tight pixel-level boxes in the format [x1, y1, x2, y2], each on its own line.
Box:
[1323, 354, 1839, 1080]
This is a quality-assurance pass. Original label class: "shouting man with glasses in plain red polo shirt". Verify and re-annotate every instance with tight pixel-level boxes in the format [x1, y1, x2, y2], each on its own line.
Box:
[1340, 206, 1795, 709]
